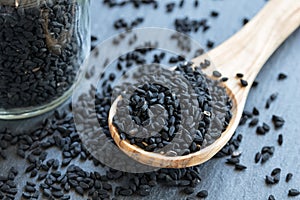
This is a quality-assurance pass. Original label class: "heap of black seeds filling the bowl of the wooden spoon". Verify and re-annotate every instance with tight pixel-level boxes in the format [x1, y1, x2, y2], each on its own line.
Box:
[114, 62, 232, 156]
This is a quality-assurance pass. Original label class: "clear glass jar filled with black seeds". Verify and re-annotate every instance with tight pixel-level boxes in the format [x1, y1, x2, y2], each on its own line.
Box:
[0, 0, 90, 119]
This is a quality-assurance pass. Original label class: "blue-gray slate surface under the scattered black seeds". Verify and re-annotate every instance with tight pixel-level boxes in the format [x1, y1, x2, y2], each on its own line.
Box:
[0, 0, 300, 200]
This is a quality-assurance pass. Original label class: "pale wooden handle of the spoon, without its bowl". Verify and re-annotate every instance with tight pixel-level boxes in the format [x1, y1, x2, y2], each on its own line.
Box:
[193, 0, 300, 88]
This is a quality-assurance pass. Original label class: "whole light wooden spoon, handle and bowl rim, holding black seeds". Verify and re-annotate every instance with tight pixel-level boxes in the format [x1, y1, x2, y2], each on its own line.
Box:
[108, 0, 300, 168]
